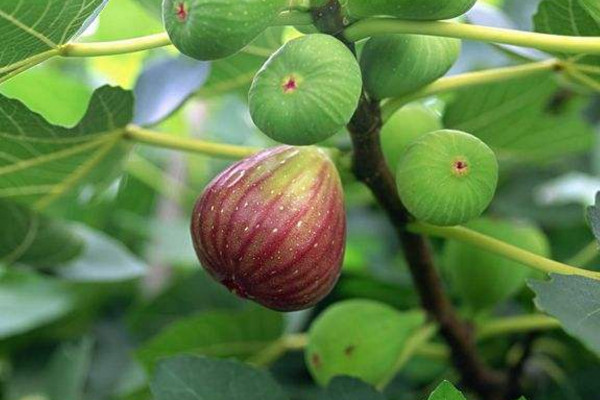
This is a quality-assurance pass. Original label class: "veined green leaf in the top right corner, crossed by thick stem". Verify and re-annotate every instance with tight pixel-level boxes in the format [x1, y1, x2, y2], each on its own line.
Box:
[534, 0, 600, 87]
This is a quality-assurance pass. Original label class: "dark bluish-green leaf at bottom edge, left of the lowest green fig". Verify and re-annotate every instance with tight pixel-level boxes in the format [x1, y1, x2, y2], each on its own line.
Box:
[150, 356, 287, 400]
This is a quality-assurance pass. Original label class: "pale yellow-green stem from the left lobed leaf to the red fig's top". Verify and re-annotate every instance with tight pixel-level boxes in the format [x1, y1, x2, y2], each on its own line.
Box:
[125, 125, 261, 160]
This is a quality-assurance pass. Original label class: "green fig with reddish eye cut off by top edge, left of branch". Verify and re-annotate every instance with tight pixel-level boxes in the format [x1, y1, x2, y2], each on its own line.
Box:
[163, 0, 288, 60]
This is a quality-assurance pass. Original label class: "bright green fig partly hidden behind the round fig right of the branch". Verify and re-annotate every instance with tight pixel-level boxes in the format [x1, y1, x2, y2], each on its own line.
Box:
[381, 103, 443, 172]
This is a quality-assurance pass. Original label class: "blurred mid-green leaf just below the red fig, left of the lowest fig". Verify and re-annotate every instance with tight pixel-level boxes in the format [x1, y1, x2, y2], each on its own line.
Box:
[138, 308, 283, 369]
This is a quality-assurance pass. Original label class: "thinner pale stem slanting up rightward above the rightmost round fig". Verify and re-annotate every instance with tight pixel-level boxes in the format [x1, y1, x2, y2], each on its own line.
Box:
[381, 59, 562, 122]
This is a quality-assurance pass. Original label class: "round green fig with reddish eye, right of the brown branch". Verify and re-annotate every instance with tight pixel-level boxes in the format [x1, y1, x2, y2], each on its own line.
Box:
[396, 130, 498, 226]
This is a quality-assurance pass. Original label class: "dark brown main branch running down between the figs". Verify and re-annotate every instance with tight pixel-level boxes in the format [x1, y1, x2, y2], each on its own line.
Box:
[313, 0, 506, 400]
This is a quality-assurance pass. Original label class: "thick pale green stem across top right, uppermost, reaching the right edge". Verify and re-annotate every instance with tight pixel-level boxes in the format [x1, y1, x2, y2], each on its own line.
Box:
[344, 18, 600, 54]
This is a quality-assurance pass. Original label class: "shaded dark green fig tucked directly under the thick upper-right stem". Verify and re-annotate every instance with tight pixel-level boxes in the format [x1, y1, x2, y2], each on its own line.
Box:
[360, 35, 461, 100]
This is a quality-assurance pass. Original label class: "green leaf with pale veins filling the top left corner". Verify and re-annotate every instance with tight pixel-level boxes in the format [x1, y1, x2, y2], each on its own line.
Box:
[0, 0, 105, 82]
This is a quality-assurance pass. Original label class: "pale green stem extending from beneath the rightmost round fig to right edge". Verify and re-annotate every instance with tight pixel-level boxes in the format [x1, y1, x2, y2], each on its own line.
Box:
[408, 222, 600, 280]
